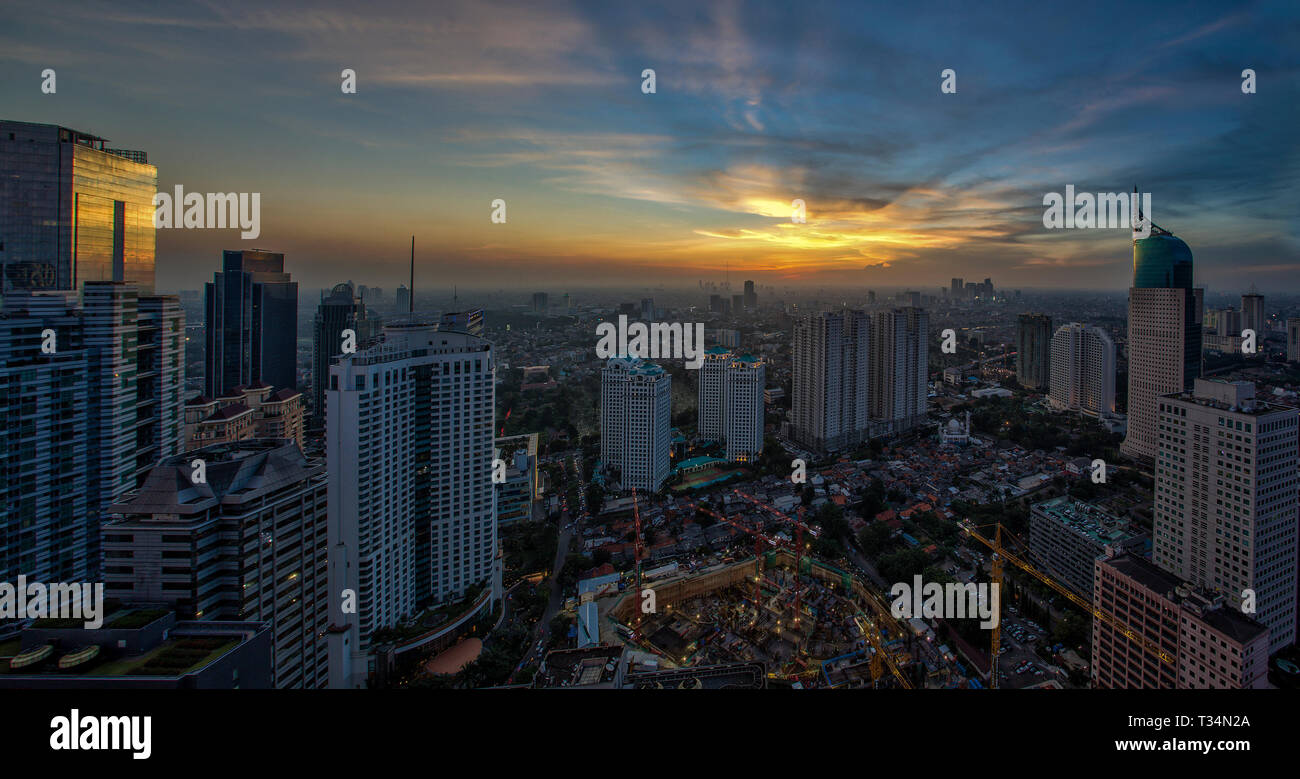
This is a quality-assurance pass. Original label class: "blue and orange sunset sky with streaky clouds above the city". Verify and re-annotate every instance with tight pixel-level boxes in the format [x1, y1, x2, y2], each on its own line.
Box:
[0, 0, 1300, 291]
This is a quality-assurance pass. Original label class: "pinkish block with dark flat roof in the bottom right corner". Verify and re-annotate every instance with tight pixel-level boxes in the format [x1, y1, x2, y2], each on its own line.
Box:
[1092, 554, 1269, 689]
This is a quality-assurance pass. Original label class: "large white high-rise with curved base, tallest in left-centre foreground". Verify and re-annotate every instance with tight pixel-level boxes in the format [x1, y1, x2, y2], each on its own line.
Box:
[325, 317, 501, 687]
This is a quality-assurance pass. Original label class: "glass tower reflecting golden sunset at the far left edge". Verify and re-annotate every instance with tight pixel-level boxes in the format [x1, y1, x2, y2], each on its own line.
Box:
[0, 121, 159, 295]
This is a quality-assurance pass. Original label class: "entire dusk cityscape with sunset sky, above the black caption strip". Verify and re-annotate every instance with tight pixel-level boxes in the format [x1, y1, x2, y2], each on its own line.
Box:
[0, 0, 1300, 712]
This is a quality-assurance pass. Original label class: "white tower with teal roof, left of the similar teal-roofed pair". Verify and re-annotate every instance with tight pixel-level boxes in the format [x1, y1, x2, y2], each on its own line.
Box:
[601, 358, 672, 493]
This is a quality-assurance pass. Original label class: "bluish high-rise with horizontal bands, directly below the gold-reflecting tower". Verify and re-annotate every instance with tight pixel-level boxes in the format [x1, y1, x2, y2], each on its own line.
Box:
[0, 281, 185, 581]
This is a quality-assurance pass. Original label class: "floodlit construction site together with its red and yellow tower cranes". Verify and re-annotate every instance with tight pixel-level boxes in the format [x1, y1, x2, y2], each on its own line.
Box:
[580, 489, 1173, 689]
